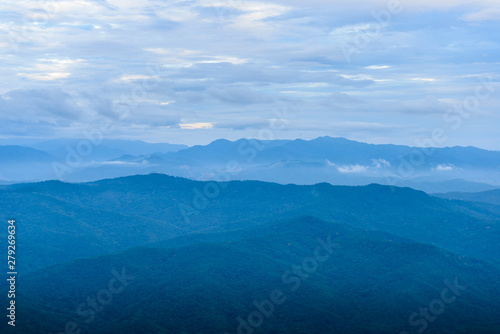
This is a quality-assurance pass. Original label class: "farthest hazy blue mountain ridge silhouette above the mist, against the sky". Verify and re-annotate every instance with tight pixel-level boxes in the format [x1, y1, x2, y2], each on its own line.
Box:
[158, 137, 500, 169]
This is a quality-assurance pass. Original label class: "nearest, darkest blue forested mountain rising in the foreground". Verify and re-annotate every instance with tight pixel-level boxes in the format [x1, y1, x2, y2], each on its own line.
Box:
[2, 217, 500, 334]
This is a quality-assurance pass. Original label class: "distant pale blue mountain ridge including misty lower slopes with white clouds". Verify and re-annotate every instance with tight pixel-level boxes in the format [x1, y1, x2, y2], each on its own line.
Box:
[0, 137, 500, 193]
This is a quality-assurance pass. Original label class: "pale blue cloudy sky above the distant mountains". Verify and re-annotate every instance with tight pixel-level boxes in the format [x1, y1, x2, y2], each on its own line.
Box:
[0, 0, 500, 150]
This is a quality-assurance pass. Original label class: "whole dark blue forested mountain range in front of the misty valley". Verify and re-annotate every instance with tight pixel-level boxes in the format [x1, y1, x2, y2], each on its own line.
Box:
[0, 174, 500, 334]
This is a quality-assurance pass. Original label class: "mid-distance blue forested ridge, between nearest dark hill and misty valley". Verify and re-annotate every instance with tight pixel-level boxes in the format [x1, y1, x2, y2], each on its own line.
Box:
[0, 174, 500, 271]
